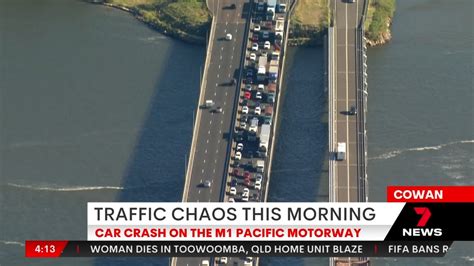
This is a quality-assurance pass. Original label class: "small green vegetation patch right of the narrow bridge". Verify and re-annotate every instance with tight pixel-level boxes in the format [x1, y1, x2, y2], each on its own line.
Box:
[365, 0, 395, 42]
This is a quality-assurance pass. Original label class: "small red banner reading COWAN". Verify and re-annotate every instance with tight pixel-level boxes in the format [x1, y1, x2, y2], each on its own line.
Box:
[387, 186, 474, 202]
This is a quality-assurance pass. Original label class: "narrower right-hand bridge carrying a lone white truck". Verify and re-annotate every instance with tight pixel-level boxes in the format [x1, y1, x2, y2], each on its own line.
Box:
[328, 0, 369, 265]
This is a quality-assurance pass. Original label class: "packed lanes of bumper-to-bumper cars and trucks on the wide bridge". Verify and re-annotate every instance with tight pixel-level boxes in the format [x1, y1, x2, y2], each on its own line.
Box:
[226, 1, 286, 202]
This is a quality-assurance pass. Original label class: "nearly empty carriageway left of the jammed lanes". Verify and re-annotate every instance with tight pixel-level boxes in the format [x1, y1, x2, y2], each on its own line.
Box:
[175, 0, 250, 266]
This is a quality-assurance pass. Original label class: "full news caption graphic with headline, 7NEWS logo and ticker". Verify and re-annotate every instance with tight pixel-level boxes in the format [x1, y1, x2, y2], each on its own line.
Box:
[25, 187, 474, 257]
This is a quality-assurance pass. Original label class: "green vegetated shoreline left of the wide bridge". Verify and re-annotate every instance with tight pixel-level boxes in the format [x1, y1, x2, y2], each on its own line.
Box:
[105, 0, 211, 43]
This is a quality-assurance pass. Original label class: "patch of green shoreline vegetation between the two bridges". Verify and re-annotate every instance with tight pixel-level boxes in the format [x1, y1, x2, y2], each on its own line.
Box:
[289, 0, 329, 45]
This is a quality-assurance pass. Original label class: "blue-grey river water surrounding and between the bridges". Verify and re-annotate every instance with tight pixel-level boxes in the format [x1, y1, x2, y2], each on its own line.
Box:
[0, 0, 474, 265]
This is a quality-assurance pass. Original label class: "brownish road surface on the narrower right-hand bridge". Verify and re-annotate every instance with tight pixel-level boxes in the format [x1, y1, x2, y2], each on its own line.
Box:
[332, 0, 364, 202]
